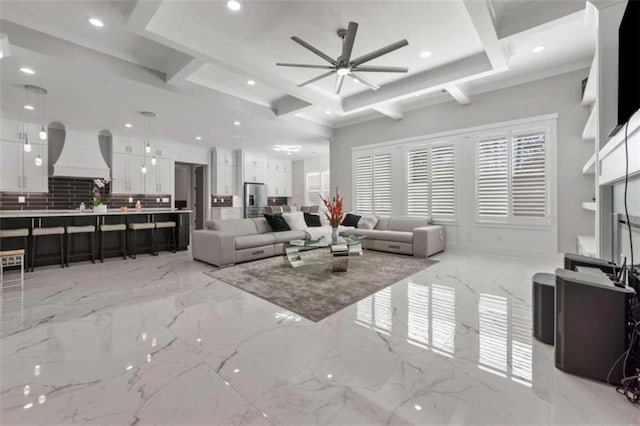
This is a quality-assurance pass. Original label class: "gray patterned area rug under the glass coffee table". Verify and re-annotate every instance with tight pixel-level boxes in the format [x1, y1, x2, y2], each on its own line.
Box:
[206, 249, 437, 322]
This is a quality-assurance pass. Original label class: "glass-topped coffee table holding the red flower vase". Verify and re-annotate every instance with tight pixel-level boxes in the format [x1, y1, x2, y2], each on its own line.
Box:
[284, 235, 366, 272]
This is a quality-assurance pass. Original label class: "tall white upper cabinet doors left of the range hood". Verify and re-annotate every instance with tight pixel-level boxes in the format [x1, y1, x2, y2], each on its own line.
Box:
[0, 141, 49, 192]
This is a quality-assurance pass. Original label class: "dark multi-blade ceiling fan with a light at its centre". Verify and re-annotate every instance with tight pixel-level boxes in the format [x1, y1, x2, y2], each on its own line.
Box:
[276, 22, 409, 94]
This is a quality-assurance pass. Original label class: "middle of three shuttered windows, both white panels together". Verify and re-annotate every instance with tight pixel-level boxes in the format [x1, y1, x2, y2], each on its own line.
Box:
[407, 144, 456, 219]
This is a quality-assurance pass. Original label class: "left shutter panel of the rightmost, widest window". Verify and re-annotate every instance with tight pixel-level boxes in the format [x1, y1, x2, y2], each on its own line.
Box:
[476, 138, 509, 217]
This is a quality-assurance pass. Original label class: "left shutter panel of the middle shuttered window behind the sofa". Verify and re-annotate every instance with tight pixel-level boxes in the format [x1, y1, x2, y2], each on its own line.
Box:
[407, 148, 429, 216]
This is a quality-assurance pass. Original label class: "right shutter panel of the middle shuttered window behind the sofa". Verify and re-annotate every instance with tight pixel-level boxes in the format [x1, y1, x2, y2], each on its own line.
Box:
[430, 145, 456, 217]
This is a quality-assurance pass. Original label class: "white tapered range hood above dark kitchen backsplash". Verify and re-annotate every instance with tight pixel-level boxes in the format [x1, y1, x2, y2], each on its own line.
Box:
[53, 129, 110, 179]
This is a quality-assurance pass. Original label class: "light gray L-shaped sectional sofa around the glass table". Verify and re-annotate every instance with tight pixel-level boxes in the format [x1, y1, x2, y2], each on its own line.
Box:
[191, 216, 445, 266]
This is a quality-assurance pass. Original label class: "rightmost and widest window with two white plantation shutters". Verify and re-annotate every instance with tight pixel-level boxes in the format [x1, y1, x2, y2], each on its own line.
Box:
[476, 131, 549, 223]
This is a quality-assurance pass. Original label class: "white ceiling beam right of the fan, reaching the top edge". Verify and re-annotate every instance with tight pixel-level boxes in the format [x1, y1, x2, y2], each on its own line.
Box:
[463, 0, 509, 71]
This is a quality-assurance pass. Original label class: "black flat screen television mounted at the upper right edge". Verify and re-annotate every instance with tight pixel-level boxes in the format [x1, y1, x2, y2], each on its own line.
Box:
[615, 0, 640, 131]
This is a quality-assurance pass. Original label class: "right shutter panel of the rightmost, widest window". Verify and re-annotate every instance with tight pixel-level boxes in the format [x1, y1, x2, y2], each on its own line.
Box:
[511, 133, 547, 217]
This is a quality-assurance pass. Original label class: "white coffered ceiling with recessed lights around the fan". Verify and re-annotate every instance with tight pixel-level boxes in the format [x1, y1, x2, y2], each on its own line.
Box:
[0, 0, 594, 156]
